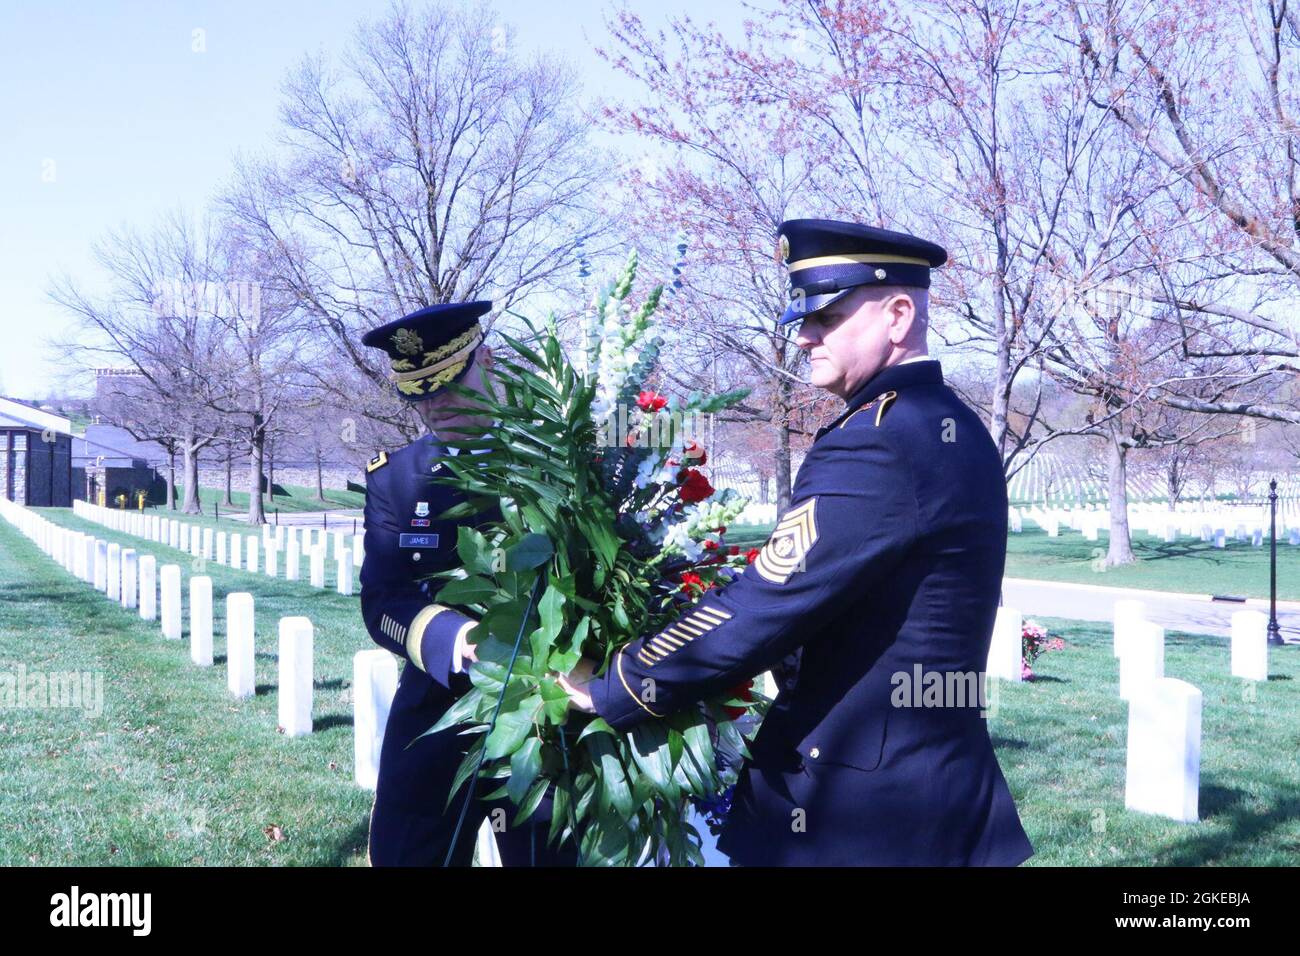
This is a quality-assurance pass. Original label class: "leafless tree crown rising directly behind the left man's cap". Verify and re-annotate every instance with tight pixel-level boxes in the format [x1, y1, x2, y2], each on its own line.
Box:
[224, 4, 608, 429]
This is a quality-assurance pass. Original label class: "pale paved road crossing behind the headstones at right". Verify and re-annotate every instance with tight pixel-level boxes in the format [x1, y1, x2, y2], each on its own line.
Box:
[1002, 578, 1300, 641]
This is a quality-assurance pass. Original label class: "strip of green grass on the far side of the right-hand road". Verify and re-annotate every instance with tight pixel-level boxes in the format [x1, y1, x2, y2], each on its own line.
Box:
[727, 522, 1300, 601]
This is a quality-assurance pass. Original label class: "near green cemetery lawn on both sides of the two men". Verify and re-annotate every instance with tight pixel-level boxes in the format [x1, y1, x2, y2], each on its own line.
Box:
[0, 510, 1300, 866]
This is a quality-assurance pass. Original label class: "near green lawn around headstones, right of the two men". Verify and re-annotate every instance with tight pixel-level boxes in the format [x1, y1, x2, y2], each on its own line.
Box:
[989, 618, 1300, 866]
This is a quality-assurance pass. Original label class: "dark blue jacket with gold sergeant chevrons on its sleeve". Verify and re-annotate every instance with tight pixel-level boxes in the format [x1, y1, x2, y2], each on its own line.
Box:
[590, 360, 1034, 865]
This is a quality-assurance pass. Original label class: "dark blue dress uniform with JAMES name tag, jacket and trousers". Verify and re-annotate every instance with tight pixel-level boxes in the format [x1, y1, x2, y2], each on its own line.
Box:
[361, 436, 572, 866]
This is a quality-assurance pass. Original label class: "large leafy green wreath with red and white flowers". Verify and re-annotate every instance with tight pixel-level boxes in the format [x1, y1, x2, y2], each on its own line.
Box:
[429, 255, 762, 865]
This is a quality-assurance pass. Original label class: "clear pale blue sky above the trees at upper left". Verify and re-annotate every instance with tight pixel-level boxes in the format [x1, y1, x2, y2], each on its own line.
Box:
[0, 0, 712, 398]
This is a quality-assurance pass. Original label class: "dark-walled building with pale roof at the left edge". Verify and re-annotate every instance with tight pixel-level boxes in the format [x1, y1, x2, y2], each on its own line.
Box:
[0, 397, 73, 507]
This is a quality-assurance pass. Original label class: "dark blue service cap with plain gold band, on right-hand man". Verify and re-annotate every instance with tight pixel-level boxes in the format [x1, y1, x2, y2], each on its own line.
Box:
[777, 219, 948, 325]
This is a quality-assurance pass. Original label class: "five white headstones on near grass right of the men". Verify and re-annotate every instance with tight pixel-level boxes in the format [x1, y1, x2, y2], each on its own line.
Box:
[987, 600, 1269, 822]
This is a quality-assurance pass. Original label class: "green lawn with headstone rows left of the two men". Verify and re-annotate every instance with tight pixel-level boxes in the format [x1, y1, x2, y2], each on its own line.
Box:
[0, 509, 374, 866]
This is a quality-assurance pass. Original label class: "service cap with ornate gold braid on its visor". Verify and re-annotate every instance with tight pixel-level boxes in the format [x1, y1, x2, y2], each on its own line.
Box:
[361, 302, 491, 402]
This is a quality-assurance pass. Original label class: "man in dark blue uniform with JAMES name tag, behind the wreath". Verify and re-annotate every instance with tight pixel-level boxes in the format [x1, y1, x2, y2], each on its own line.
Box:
[361, 302, 573, 866]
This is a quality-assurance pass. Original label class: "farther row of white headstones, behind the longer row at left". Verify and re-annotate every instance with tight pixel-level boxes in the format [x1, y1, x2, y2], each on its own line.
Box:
[73, 501, 365, 594]
